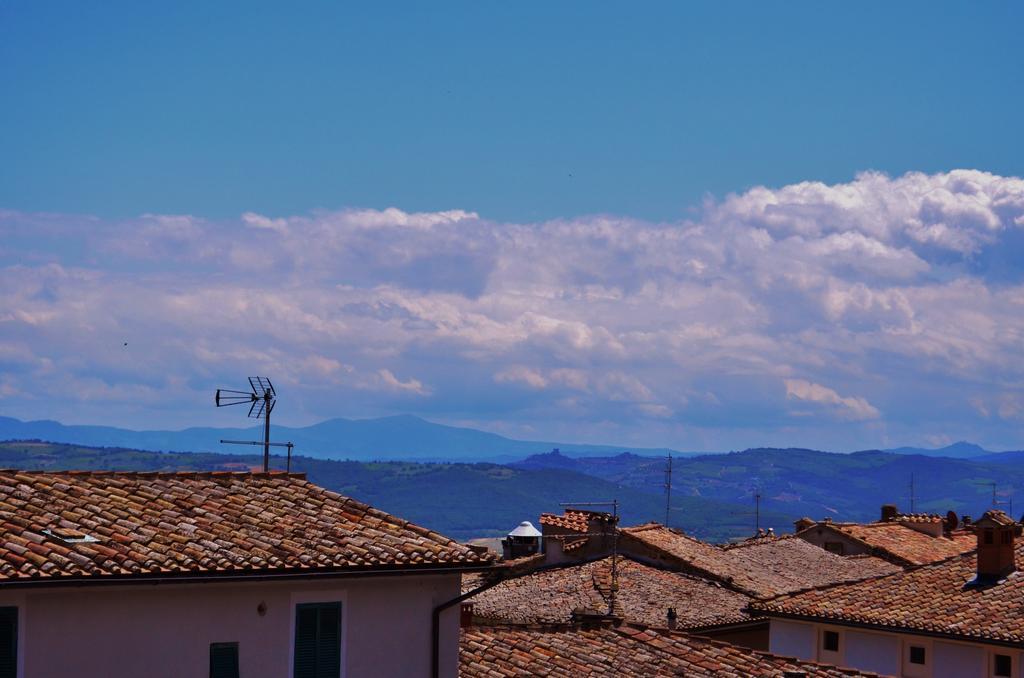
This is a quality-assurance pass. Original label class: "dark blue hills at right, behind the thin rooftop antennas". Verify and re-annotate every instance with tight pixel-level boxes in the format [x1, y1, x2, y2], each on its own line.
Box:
[518, 449, 1024, 529]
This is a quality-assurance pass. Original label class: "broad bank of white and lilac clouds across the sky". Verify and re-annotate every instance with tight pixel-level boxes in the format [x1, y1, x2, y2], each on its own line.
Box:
[0, 170, 1024, 449]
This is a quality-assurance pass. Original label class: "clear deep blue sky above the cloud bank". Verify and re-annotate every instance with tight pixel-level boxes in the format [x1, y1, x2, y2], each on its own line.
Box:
[0, 2, 1024, 221]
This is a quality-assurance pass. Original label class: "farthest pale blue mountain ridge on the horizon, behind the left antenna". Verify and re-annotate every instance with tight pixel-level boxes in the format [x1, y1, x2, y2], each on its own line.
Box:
[0, 416, 682, 461]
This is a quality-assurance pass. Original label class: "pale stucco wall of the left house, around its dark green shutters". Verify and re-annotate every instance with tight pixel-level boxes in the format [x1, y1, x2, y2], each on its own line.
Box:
[0, 575, 460, 678]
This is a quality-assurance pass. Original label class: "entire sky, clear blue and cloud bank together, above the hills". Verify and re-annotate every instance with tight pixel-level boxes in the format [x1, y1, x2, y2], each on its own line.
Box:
[0, 2, 1024, 449]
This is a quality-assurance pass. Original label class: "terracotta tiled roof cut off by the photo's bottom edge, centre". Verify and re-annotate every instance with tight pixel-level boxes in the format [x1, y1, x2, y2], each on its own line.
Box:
[459, 625, 872, 678]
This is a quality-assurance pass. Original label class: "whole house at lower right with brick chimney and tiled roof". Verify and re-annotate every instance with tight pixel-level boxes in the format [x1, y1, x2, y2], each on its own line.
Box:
[751, 511, 1024, 678]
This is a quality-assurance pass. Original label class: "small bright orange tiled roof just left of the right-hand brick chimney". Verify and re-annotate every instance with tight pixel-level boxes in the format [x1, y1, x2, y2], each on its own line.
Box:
[808, 522, 978, 565]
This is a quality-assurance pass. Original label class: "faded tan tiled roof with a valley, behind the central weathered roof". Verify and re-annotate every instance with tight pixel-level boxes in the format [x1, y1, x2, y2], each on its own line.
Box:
[623, 524, 899, 598]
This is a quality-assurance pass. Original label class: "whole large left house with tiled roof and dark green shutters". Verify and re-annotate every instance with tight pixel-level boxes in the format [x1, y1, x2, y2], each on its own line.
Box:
[0, 471, 490, 678]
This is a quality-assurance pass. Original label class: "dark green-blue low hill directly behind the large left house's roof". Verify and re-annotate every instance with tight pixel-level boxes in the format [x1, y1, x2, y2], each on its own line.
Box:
[0, 440, 774, 541]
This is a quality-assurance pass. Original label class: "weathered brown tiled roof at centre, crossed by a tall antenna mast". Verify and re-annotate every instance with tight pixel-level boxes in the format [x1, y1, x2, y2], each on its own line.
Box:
[463, 557, 751, 628]
